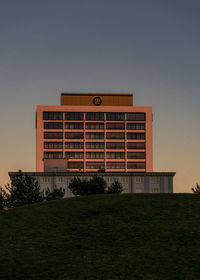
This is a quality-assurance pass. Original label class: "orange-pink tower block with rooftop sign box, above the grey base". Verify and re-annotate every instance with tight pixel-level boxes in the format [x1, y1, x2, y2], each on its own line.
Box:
[36, 93, 153, 172]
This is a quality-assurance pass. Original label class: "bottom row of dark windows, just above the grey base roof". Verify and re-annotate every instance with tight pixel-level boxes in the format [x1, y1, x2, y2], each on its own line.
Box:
[68, 161, 146, 170]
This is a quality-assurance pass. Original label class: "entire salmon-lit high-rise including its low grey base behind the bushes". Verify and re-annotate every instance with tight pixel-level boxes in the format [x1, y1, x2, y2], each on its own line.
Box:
[9, 93, 175, 194]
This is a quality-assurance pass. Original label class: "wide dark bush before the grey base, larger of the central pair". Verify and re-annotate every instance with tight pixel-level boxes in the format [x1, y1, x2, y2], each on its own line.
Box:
[69, 177, 107, 195]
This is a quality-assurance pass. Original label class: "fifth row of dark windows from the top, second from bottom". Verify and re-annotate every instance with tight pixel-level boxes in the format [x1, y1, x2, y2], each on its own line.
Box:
[44, 152, 146, 159]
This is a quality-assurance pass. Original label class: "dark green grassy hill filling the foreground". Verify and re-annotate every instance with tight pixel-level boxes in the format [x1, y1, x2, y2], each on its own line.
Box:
[0, 194, 200, 280]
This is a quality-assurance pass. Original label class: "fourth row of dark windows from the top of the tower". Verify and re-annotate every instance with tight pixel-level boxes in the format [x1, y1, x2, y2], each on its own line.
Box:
[44, 142, 145, 150]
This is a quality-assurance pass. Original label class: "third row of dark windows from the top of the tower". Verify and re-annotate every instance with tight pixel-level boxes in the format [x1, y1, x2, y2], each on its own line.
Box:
[44, 132, 145, 140]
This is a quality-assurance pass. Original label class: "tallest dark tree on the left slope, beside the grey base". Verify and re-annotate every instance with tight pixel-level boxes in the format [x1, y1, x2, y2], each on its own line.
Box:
[6, 170, 44, 207]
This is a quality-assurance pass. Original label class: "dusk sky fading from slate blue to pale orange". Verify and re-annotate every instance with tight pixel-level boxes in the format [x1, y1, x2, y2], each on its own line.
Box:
[0, 0, 200, 192]
